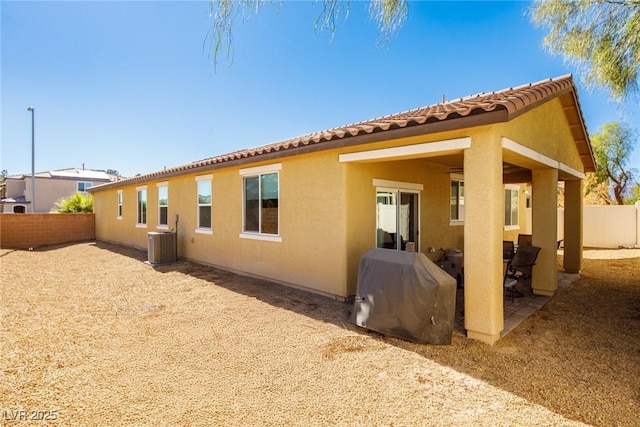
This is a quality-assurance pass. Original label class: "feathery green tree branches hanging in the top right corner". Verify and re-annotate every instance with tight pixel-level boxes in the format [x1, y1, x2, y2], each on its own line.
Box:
[531, 0, 640, 99]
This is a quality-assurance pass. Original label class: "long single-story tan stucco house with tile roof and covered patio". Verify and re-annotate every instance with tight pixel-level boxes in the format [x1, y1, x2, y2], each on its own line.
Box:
[89, 76, 595, 343]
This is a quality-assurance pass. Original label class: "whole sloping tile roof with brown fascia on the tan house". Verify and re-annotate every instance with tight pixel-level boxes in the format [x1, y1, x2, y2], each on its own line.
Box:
[90, 75, 595, 191]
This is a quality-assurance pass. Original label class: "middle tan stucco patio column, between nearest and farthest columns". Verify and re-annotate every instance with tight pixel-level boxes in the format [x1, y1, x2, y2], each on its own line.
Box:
[531, 168, 558, 296]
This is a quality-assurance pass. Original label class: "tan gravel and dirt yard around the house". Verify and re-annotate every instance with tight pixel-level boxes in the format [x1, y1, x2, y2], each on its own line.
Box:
[0, 243, 640, 426]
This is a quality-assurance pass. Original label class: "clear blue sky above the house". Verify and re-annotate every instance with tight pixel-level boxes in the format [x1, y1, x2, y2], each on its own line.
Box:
[0, 0, 640, 176]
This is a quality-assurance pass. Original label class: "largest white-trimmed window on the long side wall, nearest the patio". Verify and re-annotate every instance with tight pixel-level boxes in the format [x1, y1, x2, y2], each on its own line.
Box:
[240, 163, 282, 242]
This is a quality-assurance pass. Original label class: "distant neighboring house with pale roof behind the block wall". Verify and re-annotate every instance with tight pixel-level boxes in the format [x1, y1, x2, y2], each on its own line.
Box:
[0, 167, 118, 213]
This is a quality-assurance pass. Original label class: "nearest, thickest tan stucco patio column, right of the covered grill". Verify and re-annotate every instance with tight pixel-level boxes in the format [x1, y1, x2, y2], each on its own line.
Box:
[464, 136, 504, 344]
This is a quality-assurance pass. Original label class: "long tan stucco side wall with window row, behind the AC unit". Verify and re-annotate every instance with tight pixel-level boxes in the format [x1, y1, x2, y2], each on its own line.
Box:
[93, 151, 347, 297]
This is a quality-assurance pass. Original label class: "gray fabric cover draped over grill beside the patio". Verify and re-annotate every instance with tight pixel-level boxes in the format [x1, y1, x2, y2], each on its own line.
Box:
[352, 248, 456, 344]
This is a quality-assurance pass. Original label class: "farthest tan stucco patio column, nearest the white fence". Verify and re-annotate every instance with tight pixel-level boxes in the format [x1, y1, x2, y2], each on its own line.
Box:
[564, 179, 583, 274]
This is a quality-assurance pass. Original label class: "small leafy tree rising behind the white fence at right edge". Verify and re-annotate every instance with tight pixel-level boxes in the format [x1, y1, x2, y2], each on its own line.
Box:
[587, 122, 637, 205]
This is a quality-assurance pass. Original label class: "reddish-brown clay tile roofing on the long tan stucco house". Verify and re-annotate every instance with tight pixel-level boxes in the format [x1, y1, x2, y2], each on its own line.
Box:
[92, 75, 593, 191]
